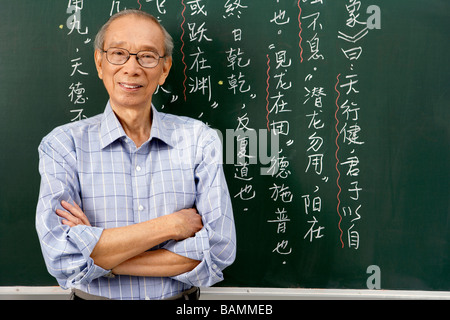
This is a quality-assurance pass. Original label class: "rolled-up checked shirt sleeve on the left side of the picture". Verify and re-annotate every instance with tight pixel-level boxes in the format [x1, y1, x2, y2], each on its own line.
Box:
[36, 136, 109, 288]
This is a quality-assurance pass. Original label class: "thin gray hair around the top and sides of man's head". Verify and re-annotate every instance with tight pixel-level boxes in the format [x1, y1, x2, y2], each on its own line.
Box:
[94, 9, 174, 57]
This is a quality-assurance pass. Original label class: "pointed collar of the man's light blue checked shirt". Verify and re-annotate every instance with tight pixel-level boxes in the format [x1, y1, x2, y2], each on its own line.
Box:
[100, 101, 173, 149]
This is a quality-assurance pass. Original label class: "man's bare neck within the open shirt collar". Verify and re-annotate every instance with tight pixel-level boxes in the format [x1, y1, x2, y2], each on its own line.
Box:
[111, 104, 152, 148]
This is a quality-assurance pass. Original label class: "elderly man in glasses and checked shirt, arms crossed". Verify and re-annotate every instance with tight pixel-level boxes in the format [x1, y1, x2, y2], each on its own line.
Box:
[36, 10, 236, 299]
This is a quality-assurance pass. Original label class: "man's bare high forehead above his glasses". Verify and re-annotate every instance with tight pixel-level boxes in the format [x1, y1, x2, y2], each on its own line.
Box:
[104, 15, 164, 50]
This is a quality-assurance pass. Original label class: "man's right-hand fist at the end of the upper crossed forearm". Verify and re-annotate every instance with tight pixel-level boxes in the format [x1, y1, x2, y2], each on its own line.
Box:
[169, 208, 203, 241]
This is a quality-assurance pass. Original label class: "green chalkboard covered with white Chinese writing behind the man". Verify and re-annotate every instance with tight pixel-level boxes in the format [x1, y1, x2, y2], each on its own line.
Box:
[0, 0, 450, 291]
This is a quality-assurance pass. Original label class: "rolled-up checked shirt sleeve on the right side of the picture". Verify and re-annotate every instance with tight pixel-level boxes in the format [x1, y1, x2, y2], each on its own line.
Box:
[164, 129, 236, 287]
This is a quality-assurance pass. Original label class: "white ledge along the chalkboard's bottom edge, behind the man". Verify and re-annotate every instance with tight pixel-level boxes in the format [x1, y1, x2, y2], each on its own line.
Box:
[0, 286, 450, 300]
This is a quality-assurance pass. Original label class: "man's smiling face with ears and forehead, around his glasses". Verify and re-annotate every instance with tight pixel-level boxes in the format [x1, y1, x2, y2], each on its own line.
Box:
[95, 15, 172, 109]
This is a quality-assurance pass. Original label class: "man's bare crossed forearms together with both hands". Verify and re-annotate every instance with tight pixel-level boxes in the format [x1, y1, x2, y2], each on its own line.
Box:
[56, 201, 203, 277]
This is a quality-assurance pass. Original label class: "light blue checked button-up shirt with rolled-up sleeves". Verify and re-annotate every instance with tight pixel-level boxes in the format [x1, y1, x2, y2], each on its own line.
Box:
[36, 103, 236, 299]
